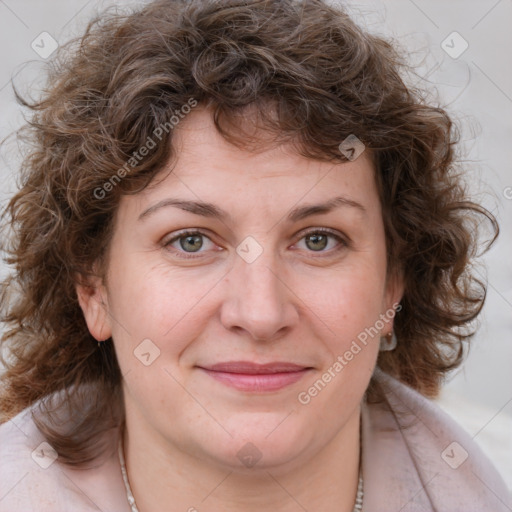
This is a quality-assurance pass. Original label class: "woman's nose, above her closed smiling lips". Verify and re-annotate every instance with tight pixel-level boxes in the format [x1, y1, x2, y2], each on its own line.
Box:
[221, 252, 299, 341]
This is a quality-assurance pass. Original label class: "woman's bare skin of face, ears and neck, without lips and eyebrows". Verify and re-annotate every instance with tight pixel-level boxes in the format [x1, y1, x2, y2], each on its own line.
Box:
[77, 108, 402, 512]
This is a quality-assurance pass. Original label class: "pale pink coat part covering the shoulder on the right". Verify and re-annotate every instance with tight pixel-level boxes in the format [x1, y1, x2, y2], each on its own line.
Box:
[362, 370, 512, 512]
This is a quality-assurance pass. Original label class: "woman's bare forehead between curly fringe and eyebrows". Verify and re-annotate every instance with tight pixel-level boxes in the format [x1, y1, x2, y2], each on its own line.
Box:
[118, 108, 378, 224]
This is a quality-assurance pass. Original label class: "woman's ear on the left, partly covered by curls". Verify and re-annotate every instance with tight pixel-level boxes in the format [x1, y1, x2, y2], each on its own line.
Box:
[75, 277, 112, 341]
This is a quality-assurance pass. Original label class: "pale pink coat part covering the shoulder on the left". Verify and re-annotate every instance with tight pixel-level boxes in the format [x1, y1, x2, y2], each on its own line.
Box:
[0, 400, 129, 512]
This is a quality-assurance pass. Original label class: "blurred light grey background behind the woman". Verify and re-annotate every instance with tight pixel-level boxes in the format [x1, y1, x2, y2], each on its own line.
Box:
[0, 0, 512, 489]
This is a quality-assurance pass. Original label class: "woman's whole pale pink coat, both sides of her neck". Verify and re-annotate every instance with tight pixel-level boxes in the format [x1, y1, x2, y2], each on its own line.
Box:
[0, 370, 512, 512]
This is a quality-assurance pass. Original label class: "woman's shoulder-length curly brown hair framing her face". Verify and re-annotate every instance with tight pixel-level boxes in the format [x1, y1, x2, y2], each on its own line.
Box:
[0, 0, 498, 465]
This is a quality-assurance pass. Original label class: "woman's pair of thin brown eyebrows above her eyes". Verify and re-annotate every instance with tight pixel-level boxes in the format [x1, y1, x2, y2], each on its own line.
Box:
[139, 196, 367, 222]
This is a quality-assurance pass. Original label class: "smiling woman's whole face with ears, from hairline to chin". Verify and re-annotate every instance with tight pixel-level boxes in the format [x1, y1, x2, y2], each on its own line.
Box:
[79, 109, 400, 476]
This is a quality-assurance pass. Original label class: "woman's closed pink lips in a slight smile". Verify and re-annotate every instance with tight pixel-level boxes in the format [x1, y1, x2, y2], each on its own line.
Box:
[198, 361, 312, 392]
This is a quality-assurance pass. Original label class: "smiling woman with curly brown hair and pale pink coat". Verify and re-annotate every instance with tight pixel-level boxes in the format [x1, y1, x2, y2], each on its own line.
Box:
[0, 0, 512, 512]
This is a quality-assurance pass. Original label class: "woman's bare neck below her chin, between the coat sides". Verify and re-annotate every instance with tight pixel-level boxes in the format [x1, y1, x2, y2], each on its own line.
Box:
[123, 408, 360, 512]
